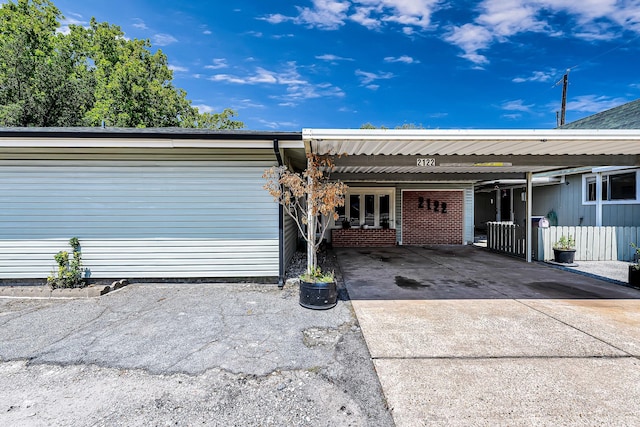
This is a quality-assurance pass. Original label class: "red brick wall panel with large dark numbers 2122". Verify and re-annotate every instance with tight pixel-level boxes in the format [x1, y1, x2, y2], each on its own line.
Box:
[402, 191, 464, 245]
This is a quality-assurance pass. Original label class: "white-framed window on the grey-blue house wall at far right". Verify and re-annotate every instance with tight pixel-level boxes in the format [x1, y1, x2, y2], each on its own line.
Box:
[582, 170, 640, 205]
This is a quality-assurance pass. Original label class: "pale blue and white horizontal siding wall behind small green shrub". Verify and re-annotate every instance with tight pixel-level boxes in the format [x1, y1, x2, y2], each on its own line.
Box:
[0, 161, 278, 278]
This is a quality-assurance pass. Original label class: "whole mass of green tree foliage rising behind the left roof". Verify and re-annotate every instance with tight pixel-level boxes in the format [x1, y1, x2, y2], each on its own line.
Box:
[0, 0, 244, 129]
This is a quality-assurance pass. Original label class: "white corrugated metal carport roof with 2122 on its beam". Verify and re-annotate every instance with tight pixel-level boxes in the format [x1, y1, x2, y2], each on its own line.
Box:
[302, 129, 640, 181]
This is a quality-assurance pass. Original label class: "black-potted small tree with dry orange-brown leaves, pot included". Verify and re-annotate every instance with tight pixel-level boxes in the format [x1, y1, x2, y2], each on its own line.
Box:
[263, 153, 347, 310]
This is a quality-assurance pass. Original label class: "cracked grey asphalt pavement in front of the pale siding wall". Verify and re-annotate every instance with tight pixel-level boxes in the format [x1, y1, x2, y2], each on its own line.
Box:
[0, 284, 393, 426]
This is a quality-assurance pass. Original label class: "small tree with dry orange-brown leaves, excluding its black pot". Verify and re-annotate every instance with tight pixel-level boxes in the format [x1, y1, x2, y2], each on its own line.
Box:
[262, 153, 348, 278]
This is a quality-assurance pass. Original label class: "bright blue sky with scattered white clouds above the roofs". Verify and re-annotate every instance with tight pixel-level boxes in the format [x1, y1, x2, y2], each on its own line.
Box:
[54, 0, 640, 131]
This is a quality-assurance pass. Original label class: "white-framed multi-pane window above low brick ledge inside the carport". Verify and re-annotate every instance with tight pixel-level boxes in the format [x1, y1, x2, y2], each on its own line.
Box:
[335, 188, 395, 228]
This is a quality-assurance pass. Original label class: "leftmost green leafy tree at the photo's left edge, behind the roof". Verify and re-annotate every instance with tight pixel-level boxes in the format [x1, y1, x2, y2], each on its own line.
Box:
[0, 0, 91, 126]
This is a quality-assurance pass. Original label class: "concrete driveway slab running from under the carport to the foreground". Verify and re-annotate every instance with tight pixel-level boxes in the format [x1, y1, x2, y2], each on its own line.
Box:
[336, 246, 640, 426]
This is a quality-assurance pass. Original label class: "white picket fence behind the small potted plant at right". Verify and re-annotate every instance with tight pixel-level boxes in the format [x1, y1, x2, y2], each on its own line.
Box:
[534, 227, 640, 261]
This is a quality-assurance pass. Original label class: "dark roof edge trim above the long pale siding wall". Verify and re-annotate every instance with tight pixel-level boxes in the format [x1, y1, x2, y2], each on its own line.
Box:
[0, 127, 302, 141]
